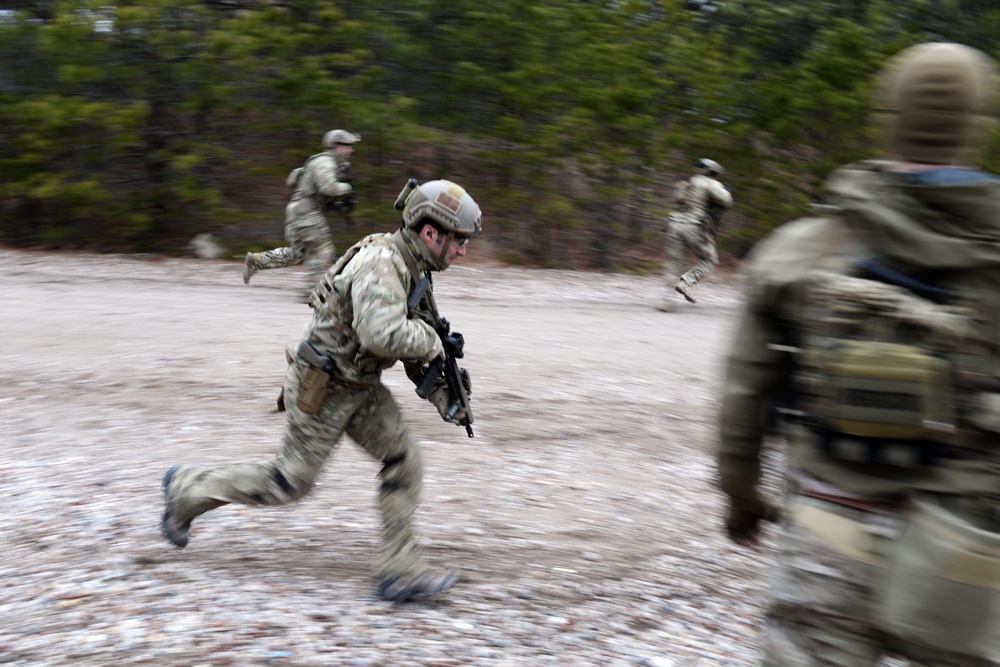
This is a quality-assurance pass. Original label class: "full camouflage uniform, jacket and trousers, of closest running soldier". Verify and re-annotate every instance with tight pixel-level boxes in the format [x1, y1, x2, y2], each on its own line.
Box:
[165, 230, 442, 578]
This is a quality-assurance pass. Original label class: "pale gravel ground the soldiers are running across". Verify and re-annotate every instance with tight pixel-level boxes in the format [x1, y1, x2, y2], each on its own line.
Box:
[0, 249, 908, 667]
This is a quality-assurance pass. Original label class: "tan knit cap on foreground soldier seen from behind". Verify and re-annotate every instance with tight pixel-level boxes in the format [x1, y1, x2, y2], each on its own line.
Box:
[878, 42, 998, 164]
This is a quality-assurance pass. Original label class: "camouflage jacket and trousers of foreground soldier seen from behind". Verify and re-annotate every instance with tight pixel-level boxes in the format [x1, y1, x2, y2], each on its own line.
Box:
[718, 162, 1000, 667]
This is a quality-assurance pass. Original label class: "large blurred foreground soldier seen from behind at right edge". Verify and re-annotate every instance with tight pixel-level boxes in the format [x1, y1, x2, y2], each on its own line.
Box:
[718, 43, 1000, 667]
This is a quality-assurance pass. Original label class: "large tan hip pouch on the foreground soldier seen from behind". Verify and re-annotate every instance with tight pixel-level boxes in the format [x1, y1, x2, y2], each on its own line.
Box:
[875, 497, 1000, 660]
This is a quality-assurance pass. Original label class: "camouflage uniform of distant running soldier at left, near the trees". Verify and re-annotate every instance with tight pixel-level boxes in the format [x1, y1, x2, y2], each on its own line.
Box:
[253, 150, 353, 295]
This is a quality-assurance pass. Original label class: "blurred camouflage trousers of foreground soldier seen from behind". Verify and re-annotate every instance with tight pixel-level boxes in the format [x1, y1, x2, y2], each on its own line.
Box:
[761, 494, 1000, 667]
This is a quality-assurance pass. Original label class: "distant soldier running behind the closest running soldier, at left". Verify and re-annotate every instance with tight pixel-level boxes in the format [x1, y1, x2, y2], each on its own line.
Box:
[243, 130, 361, 298]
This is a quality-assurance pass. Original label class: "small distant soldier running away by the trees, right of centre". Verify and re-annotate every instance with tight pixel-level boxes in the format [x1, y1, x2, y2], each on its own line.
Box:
[657, 159, 733, 312]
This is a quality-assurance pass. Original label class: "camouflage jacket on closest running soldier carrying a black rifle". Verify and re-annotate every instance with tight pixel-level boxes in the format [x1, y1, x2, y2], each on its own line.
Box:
[303, 230, 441, 385]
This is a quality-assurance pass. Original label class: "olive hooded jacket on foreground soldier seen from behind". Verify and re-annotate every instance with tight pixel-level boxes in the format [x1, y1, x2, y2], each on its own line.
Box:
[717, 161, 1000, 499]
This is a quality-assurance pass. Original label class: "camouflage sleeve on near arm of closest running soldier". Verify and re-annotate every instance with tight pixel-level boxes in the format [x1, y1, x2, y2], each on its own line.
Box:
[351, 245, 441, 359]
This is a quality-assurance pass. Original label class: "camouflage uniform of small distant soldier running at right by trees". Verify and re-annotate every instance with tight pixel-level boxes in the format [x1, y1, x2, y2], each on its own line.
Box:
[663, 174, 733, 308]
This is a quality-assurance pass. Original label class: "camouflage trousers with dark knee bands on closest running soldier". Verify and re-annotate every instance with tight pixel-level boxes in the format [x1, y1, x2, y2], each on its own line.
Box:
[170, 363, 427, 576]
